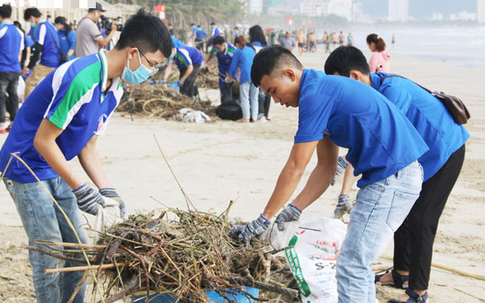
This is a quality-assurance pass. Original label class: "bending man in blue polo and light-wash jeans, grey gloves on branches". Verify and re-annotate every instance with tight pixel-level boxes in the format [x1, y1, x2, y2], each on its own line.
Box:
[229, 46, 428, 303]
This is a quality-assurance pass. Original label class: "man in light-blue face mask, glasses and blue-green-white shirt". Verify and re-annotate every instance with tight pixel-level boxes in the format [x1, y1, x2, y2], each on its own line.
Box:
[0, 10, 172, 303]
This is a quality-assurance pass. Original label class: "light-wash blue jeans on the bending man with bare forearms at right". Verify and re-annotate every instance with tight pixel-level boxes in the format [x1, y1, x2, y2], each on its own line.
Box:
[337, 161, 423, 303]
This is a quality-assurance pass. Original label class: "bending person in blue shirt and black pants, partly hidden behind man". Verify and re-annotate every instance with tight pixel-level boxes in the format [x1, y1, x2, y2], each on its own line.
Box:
[325, 46, 470, 303]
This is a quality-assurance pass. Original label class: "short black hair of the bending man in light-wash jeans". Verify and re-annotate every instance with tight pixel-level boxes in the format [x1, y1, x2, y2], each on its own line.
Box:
[251, 45, 303, 86]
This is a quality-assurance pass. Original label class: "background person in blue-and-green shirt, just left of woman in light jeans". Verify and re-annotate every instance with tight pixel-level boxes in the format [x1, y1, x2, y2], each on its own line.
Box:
[207, 36, 236, 103]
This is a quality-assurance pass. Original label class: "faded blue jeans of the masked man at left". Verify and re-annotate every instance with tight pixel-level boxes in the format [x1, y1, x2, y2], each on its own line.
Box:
[4, 178, 88, 303]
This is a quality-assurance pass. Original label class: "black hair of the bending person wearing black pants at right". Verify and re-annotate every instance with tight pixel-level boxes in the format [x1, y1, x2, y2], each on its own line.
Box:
[325, 46, 370, 77]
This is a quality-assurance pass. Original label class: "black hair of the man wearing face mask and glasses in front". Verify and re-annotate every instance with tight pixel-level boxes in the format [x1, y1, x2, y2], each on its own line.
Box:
[115, 9, 172, 58]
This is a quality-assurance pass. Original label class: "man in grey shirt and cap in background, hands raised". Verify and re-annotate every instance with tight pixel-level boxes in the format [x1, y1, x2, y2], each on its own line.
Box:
[76, 2, 117, 58]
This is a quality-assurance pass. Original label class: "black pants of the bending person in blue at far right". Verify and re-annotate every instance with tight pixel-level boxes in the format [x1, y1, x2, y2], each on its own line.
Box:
[394, 145, 465, 290]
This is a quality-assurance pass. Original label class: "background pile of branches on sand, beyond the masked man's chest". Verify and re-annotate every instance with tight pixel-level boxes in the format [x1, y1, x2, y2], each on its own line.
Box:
[116, 82, 216, 119]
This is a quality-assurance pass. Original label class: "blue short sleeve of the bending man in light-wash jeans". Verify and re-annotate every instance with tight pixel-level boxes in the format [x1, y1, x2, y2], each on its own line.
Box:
[295, 95, 334, 143]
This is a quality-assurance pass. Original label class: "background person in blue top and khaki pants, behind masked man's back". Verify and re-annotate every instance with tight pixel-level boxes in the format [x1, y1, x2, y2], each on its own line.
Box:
[22, 7, 61, 98]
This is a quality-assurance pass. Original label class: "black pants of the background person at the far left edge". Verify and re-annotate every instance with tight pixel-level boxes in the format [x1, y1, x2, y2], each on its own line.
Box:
[0, 72, 20, 123]
